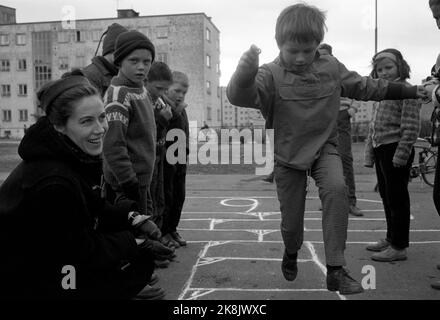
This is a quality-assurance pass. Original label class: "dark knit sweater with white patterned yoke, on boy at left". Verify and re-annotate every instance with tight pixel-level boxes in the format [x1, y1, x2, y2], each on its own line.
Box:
[103, 74, 156, 187]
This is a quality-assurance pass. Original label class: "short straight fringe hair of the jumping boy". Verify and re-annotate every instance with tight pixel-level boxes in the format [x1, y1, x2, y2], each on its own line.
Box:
[275, 3, 327, 46]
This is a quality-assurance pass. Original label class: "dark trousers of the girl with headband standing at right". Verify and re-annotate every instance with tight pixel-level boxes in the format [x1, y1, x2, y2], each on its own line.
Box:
[374, 142, 414, 250]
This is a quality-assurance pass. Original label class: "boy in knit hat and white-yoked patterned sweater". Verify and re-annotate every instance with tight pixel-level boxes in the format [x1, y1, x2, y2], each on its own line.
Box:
[103, 31, 156, 218]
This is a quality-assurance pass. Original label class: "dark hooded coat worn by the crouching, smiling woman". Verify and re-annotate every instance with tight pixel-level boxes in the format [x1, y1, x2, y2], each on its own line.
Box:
[0, 117, 146, 299]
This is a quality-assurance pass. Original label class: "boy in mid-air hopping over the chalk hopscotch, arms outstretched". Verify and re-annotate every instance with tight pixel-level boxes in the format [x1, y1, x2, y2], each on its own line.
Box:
[227, 4, 426, 294]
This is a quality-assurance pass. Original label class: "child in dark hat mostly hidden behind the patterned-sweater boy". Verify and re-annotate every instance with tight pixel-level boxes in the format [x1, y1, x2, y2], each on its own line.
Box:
[82, 23, 128, 97]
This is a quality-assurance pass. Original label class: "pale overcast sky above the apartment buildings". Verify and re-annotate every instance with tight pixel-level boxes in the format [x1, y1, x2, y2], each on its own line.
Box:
[1, 0, 440, 85]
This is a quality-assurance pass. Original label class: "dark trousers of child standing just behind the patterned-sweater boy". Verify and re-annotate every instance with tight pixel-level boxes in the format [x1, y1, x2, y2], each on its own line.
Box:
[150, 145, 165, 228]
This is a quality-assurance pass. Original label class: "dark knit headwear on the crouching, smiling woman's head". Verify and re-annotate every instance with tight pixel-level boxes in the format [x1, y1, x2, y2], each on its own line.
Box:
[37, 70, 91, 114]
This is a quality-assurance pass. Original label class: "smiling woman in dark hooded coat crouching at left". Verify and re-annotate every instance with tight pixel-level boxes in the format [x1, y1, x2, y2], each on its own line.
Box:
[0, 75, 161, 299]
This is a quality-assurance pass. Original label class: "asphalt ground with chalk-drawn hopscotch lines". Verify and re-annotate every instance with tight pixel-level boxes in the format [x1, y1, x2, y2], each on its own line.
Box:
[157, 175, 440, 300]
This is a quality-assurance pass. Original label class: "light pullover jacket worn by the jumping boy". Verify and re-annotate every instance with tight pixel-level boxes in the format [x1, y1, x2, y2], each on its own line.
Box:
[227, 53, 417, 170]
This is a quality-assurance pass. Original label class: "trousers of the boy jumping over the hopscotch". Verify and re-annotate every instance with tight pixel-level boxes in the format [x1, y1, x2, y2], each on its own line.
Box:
[274, 143, 349, 266]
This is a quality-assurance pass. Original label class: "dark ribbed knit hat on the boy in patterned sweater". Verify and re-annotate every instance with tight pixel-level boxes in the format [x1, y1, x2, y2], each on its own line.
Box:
[113, 30, 155, 66]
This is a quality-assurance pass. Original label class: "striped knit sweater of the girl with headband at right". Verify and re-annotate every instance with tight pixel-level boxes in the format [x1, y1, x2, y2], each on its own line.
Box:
[365, 80, 421, 167]
